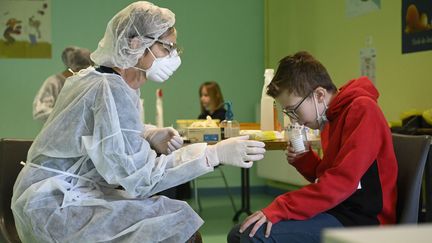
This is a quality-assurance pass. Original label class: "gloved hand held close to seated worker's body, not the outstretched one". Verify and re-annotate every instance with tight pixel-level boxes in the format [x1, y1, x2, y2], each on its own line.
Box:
[143, 127, 183, 154]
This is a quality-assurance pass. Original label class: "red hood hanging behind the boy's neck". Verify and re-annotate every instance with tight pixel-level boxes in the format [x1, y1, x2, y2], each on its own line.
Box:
[326, 77, 379, 120]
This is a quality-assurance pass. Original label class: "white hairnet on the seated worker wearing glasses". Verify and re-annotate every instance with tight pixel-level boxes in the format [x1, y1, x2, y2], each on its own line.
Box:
[91, 1, 175, 68]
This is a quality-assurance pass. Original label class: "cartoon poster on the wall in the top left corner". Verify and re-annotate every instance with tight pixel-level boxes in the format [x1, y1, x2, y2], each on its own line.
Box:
[0, 0, 52, 58]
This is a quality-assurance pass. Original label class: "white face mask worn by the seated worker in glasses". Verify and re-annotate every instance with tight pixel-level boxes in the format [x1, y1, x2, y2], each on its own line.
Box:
[134, 49, 181, 83]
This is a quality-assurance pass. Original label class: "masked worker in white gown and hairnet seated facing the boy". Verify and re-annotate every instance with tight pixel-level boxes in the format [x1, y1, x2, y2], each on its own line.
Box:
[11, 1, 265, 243]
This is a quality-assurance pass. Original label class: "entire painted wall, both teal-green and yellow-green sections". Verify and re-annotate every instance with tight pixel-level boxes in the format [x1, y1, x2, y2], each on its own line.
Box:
[0, 0, 432, 190]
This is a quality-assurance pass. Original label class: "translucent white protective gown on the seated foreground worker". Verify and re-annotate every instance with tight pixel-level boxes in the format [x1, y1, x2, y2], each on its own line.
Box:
[11, 68, 213, 243]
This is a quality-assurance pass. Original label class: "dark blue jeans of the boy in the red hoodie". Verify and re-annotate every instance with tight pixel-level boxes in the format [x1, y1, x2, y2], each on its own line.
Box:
[227, 213, 343, 243]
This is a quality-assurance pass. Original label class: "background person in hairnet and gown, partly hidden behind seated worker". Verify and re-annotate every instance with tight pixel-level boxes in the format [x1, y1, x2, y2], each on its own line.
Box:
[33, 46, 93, 122]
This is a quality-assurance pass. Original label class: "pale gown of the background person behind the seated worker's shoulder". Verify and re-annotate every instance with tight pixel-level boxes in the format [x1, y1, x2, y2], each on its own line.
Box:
[33, 73, 66, 122]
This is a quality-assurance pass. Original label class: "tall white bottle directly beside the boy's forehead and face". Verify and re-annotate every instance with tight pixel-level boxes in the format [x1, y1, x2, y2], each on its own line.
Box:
[260, 69, 275, 131]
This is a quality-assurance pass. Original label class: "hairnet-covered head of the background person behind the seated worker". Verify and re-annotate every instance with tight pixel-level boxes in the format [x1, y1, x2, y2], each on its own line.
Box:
[62, 46, 93, 72]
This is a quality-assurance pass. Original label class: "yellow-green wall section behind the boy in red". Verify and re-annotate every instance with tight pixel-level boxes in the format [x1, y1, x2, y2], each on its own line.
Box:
[265, 0, 432, 120]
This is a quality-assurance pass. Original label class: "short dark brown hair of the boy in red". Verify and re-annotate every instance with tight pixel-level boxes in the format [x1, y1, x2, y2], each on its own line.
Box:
[267, 51, 337, 98]
